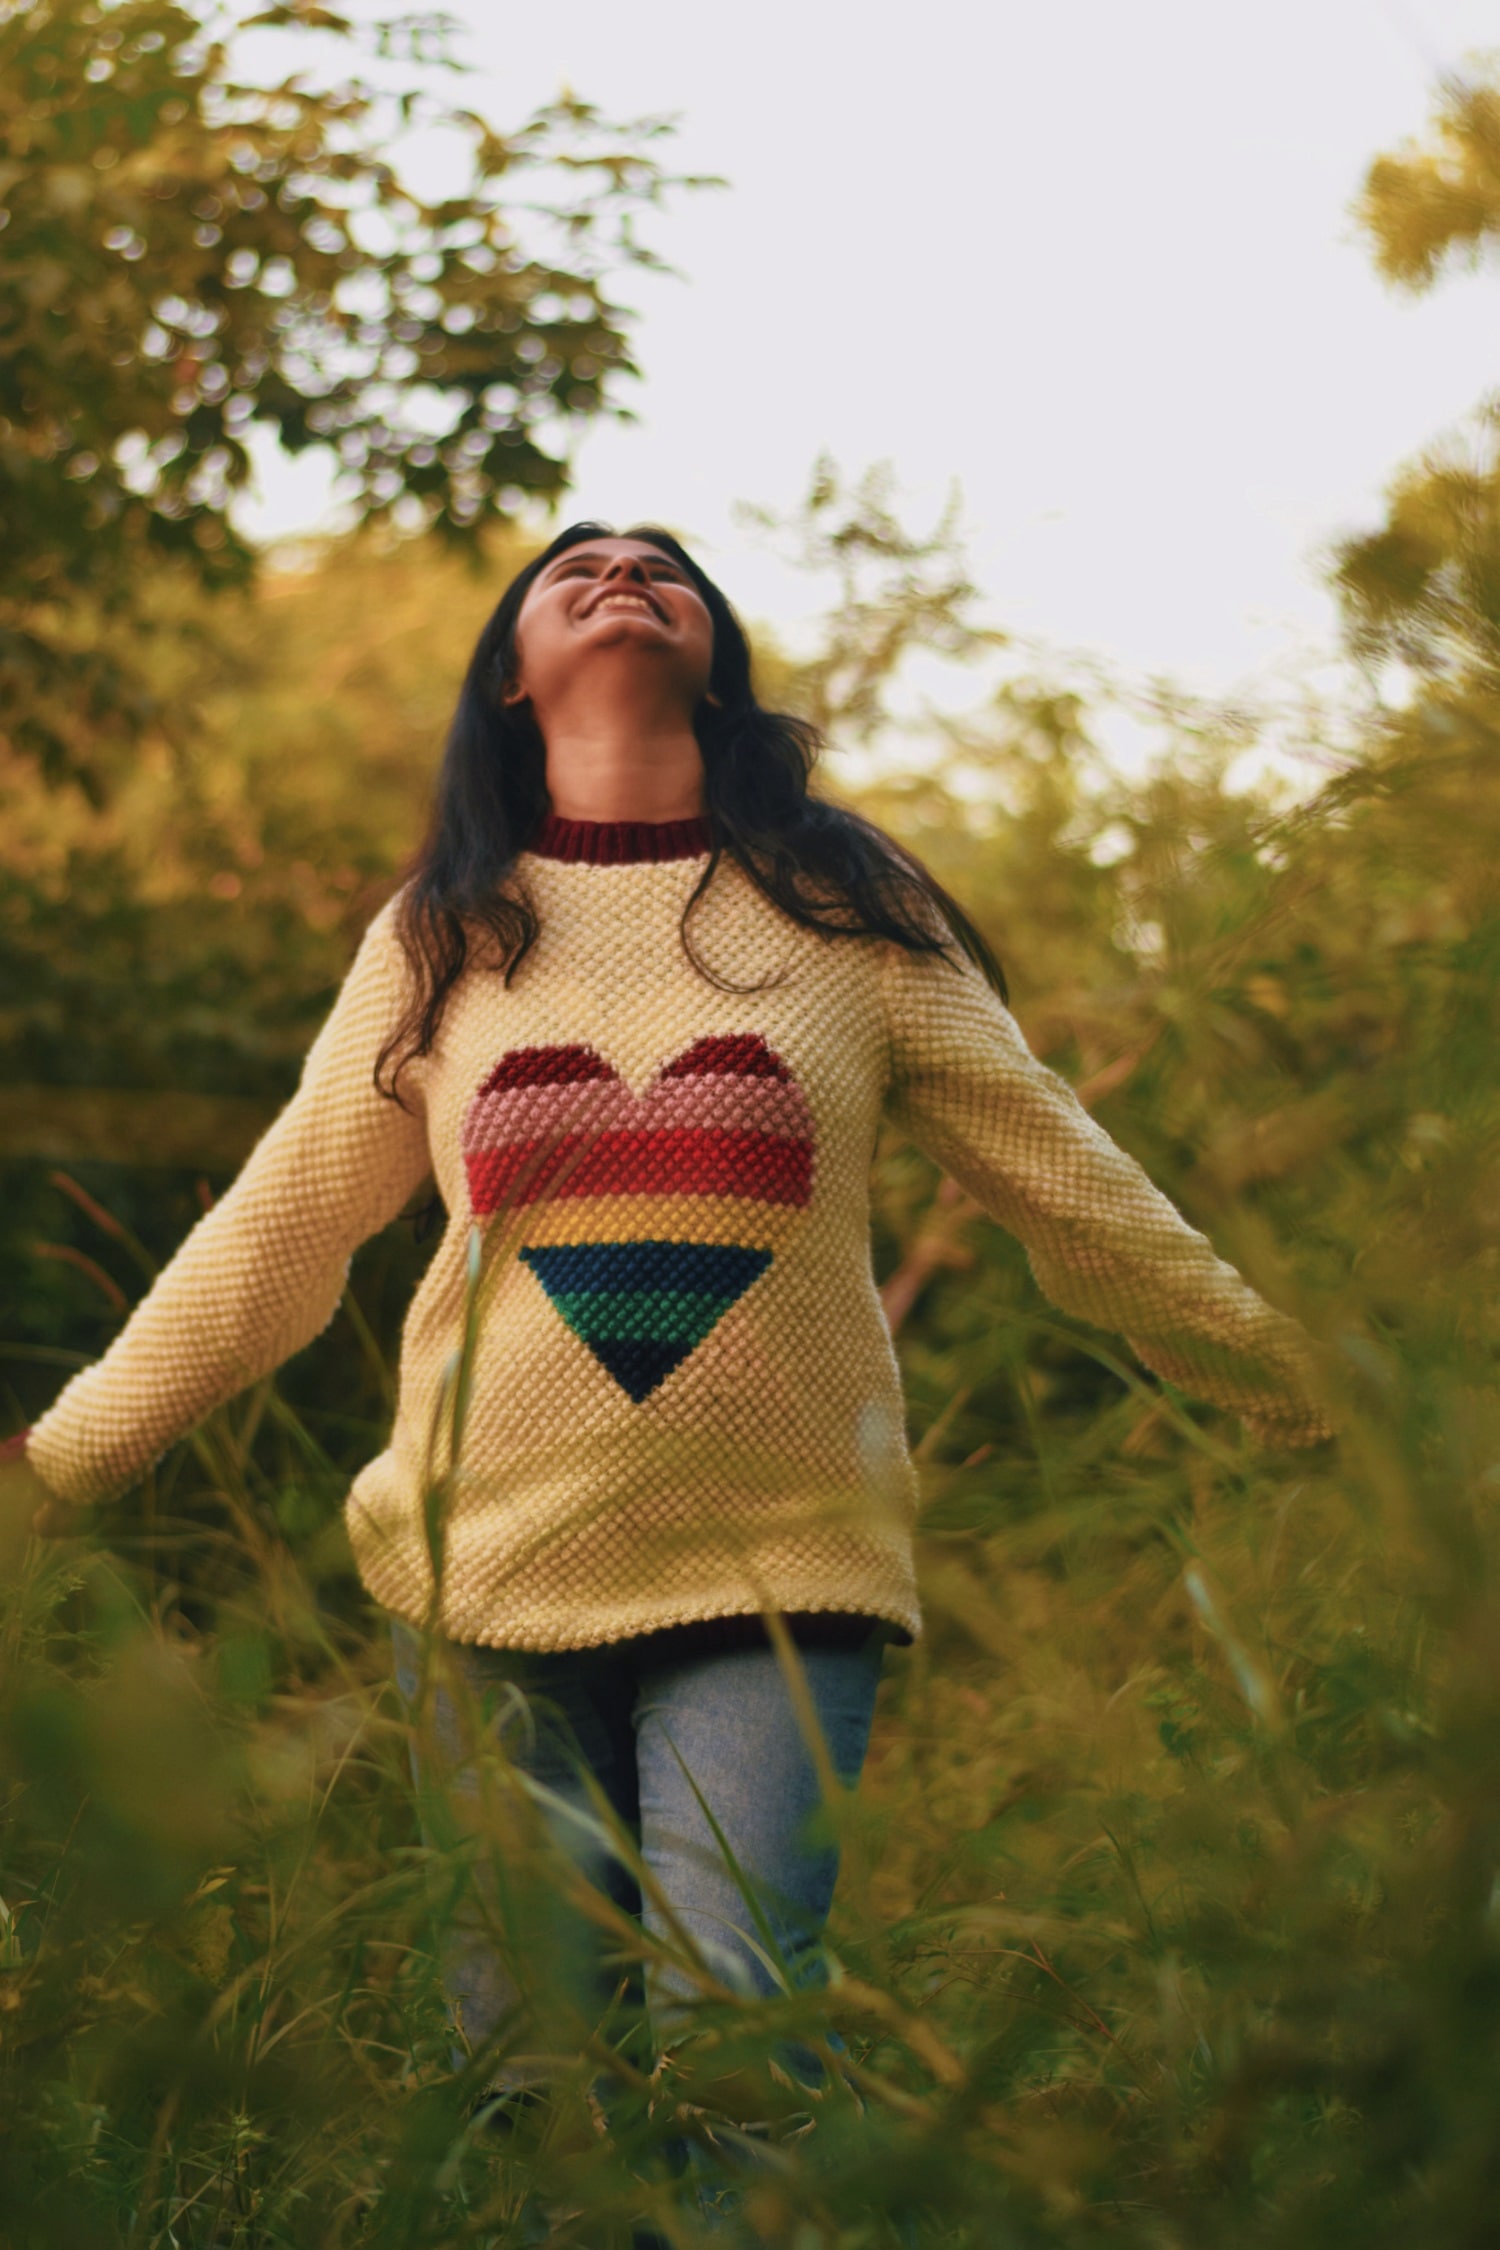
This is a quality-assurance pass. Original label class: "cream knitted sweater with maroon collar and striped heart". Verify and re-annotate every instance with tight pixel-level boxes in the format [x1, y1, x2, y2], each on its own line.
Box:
[27, 819, 1329, 1649]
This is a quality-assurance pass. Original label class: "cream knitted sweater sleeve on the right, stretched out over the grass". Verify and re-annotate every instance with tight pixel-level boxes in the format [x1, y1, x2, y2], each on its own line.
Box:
[882, 950, 1334, 1447]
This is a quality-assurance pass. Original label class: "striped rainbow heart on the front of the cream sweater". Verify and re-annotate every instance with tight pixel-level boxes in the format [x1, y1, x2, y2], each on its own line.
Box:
[463, 1033, 814, 1404]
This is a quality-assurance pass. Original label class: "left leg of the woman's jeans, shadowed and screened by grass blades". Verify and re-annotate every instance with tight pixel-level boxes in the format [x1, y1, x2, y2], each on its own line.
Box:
[394, 1620, 639, 2088]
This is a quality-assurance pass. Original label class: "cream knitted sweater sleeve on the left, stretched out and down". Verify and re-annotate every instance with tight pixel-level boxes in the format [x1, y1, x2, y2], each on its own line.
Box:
[27, 902, 430, 1503]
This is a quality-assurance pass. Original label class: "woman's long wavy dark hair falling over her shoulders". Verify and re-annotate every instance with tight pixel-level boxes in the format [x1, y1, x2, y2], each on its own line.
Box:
[376, 522, 1007, 1100]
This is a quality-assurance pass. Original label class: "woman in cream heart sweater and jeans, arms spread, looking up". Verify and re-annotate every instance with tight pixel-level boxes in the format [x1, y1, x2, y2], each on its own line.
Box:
[2, 524, 1329, 2178]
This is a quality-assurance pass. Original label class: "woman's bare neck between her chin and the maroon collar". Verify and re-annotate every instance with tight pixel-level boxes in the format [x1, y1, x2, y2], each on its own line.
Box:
[542, 695, 704, 821]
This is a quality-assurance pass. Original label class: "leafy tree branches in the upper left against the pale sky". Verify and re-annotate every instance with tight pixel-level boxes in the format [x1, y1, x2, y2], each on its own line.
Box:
[0, 0, 706, 788]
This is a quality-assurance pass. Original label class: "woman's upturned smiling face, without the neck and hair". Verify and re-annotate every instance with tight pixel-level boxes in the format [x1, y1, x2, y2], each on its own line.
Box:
[506, 538, 713, 720]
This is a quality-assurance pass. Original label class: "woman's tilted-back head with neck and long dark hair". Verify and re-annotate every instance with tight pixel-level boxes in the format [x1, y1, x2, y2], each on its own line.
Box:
[380, 522, 1005, 1089]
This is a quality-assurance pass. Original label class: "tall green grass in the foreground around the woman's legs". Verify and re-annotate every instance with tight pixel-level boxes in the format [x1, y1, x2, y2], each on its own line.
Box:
[0, 1179, 1500, 2250]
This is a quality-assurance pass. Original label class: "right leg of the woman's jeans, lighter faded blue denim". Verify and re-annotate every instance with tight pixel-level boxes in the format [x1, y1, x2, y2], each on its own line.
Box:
[634, 1629, 886, 2075]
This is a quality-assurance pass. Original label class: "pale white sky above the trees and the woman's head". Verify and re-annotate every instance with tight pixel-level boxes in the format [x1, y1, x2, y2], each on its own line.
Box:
[240, 0, 1500, 729]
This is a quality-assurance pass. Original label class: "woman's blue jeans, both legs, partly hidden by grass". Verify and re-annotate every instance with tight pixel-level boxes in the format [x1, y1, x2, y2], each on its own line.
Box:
[394, 1620, 888, 2088]
